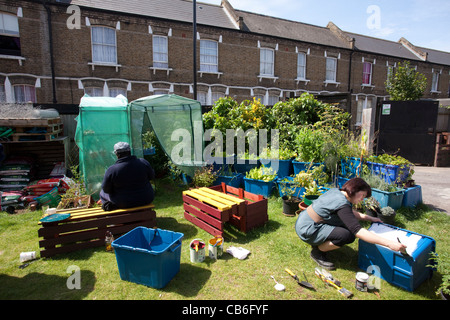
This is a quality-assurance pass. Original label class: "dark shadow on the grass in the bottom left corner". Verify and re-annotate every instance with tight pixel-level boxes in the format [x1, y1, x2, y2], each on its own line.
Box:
[0, 270, 95, 300]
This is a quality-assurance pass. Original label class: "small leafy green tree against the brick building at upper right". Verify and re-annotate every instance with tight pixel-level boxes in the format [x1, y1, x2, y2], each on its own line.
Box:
[385, 61, 427, 101]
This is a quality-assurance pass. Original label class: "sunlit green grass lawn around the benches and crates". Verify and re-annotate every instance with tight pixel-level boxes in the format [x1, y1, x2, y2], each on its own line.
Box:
[0, 180, 450, 300]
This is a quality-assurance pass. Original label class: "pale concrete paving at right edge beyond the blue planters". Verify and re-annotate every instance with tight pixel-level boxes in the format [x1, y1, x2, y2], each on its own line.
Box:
[413, 166, 450, 215]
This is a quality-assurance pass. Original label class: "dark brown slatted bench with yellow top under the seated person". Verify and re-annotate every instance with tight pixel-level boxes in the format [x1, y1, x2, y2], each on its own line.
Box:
[38, 204, 156, 257]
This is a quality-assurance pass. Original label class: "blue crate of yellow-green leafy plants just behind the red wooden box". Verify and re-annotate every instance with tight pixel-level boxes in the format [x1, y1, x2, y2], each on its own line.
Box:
[244, 166, 277, 198]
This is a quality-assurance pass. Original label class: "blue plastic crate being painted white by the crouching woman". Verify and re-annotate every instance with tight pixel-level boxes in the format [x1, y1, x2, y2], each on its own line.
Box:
[358, 224, 436, 291]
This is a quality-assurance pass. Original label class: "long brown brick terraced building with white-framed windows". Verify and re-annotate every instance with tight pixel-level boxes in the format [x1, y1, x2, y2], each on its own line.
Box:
[0, 0, 450, 125]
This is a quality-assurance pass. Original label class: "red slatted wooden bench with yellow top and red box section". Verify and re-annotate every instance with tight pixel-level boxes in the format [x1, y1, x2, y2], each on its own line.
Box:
[183, 183, 268, 236]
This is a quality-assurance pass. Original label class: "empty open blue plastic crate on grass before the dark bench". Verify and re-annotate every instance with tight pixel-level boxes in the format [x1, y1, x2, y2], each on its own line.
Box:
[112, 227, 184, 289]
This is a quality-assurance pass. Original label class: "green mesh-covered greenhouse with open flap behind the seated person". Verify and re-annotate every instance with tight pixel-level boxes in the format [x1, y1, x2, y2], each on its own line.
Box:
[75, 94, 204, 199]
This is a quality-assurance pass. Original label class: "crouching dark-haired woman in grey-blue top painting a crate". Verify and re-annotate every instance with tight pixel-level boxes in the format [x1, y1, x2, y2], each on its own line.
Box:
[295, 178, 406, 270]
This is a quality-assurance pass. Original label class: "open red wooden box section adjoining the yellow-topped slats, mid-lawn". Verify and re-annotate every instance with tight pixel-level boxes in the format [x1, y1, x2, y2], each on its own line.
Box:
[210, 182, 269, 232]
